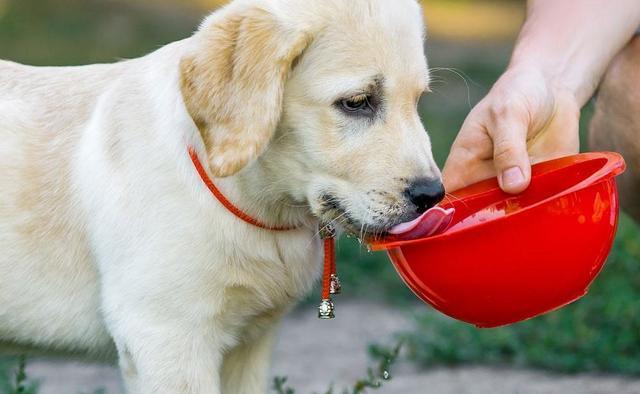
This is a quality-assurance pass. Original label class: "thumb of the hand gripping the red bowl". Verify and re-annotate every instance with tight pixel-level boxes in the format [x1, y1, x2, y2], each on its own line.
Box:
[490, 121, 531, 194]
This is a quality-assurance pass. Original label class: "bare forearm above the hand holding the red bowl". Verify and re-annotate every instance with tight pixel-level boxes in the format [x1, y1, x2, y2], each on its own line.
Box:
[510, 0, 640, 106]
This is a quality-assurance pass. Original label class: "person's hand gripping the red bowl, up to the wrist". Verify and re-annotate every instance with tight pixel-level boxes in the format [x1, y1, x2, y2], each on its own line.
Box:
[443, 67, 580, 193]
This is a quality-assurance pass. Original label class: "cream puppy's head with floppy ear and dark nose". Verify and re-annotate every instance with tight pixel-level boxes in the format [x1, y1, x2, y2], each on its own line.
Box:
[182, 0, 444, 237]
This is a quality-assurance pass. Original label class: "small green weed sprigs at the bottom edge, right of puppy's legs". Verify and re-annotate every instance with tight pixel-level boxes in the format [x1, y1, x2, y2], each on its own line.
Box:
[272, 342, 402, 394]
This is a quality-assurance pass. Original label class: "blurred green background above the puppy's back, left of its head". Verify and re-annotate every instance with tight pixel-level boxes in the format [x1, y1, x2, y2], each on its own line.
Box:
[0, 0, 198, 65]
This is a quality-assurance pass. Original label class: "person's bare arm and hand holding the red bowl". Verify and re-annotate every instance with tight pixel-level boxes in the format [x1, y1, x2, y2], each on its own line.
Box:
[444, 0, 640, 193]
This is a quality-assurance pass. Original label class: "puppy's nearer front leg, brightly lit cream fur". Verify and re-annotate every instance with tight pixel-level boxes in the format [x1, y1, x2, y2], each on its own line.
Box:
[103, 285, 226, 394]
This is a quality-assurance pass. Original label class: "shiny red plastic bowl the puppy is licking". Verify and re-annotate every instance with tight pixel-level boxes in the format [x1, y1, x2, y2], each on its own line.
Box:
[371, 153, 625, 327]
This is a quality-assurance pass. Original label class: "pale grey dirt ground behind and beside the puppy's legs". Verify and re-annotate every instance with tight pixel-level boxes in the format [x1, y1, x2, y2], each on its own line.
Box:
[28, 301, 640, 394]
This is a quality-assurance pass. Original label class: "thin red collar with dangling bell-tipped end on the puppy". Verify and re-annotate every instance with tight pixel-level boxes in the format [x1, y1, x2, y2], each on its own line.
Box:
[189, 147, 341, 319]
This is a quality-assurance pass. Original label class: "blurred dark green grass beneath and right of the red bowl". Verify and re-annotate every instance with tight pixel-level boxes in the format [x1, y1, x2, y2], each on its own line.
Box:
[403, 218, 640, 375]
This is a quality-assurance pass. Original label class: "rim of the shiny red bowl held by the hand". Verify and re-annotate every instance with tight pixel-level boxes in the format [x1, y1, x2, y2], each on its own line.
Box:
[369, 152, 626, 251]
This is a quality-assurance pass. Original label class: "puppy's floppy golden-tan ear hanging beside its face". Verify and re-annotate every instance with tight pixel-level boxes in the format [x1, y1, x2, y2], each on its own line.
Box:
[180, 7, 311, 177]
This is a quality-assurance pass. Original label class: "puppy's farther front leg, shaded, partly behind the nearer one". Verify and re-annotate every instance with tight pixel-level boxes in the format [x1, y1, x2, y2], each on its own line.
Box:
[221, 319, 277, 394]
